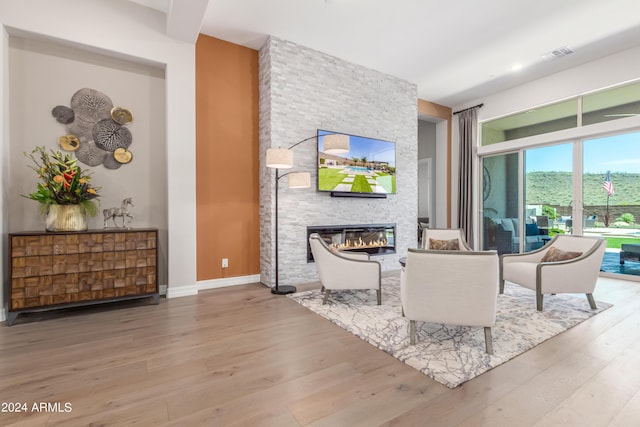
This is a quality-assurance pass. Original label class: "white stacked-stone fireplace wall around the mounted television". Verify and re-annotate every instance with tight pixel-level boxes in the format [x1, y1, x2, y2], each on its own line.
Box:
[259, 37, 418, 286]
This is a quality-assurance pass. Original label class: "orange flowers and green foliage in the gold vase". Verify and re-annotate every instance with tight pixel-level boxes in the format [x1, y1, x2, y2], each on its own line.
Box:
[24, 146, 100, 216]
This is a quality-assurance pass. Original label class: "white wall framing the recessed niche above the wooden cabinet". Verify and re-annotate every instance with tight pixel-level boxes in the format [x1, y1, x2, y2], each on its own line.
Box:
[0, 0, 197, 320]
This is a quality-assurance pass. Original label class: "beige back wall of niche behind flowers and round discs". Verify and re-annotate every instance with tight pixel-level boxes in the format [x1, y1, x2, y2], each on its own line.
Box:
[9, 37, 167, 234]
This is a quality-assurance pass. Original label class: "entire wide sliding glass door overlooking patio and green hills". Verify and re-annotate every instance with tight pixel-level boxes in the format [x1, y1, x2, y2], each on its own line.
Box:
[479, 132, 640, 276]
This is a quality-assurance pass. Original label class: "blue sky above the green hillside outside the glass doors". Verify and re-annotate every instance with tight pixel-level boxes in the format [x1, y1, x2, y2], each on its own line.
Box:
[526, 132, 640, 174]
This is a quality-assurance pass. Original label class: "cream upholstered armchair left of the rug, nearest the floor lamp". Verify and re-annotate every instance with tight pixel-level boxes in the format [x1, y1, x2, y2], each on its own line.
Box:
[309, 233, 382, 305]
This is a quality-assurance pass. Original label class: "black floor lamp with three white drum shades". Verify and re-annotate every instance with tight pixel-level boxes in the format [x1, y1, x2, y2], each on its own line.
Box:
[266, 133, 349, 295]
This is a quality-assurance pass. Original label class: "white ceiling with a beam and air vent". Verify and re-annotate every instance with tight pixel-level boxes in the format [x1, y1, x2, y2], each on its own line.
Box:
[131, 0, 640, 108]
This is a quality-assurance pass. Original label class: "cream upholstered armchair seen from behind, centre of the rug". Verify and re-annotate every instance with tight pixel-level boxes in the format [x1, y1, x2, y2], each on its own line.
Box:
[400, 249, 498, 354]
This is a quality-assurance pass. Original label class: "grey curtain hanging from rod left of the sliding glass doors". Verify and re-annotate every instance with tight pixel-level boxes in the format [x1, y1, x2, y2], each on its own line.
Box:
[458, 106, 480, 247]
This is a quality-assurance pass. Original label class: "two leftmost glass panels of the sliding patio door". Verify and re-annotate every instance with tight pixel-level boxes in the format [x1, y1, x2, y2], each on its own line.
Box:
[481, 143, 573, 254]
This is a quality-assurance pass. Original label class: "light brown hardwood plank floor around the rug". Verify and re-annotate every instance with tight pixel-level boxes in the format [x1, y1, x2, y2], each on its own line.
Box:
[0, 278, 640, 427]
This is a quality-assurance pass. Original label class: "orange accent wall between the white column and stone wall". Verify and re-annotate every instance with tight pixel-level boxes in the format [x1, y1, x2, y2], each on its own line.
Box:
[195, 34, 260, 280]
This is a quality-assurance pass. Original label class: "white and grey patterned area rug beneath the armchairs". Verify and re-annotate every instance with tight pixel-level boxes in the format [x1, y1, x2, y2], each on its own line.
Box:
[288, 277, 611, 388]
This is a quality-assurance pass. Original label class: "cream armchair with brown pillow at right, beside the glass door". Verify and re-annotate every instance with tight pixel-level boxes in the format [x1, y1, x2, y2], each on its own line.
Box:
[500, 234, 607, 311]
